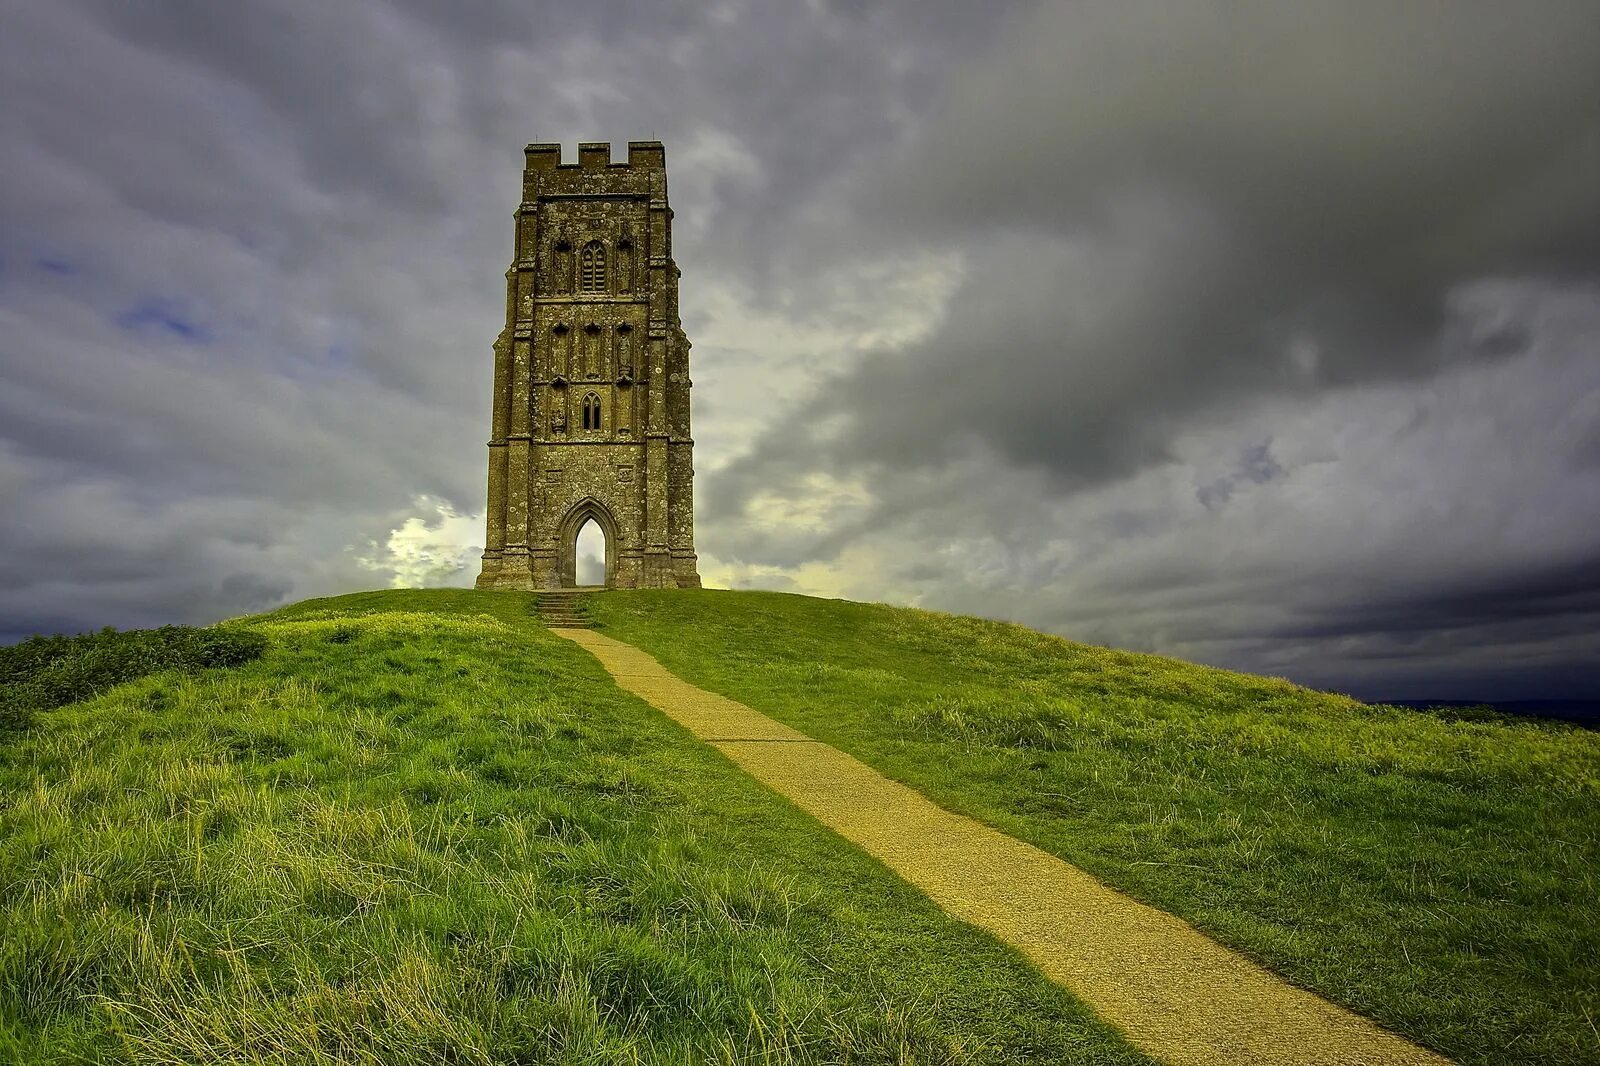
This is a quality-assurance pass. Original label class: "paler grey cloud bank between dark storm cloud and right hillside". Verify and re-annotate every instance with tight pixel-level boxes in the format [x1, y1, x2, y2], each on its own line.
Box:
[717, 273, 1600, 698]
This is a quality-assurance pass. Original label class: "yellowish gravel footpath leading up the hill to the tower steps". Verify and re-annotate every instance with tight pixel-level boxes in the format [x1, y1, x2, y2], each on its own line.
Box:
[554, 629, 1448, 1066]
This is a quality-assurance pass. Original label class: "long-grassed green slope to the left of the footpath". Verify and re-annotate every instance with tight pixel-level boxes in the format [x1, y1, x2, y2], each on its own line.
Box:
[0, 592, 1144, 1064]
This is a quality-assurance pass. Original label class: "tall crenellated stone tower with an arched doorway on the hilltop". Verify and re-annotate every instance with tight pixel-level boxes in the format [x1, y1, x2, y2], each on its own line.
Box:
[477, 141, 699, 589]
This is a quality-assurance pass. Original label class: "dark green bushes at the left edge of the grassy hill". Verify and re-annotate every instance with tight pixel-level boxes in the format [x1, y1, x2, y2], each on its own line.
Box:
[0, 626, 267, 730]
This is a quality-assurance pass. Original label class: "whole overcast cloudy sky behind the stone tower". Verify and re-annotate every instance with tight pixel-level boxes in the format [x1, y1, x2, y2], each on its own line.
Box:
[0, 0, 1600, 698]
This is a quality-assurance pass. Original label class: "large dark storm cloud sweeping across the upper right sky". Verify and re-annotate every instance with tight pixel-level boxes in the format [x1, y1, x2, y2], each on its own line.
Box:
[718, 3, 1600, 507]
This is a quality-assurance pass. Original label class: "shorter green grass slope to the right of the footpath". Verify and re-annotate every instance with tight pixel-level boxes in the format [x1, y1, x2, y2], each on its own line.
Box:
[590, 592, 1600, 1063]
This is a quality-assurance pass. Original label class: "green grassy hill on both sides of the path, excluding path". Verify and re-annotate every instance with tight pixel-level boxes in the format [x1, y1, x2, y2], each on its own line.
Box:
[0, 591, 1600, 1063]
